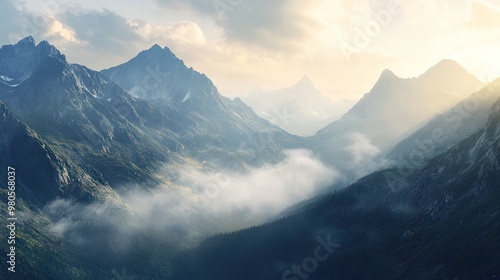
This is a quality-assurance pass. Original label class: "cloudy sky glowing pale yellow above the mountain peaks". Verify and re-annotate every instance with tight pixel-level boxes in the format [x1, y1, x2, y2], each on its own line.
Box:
[0, 0, 500, 114]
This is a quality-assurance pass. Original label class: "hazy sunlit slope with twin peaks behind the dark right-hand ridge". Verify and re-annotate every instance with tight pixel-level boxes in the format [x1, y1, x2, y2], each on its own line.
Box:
[310, 60, 481, 180]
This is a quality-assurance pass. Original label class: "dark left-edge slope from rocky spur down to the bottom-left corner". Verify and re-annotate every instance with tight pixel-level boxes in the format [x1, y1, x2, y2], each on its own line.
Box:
[0, 101, 122, 280]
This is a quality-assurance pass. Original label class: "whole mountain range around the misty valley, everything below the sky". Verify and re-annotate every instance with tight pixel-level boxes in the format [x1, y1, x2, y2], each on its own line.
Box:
[0, 37, 500, 280]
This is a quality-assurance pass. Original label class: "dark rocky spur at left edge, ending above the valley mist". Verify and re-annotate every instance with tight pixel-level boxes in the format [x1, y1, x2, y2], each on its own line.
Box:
[0, 101, 113, 207]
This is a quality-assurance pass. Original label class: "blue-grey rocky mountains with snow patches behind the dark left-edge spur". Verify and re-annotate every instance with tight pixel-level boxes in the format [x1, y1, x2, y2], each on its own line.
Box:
[0, 38, 296, 195]
